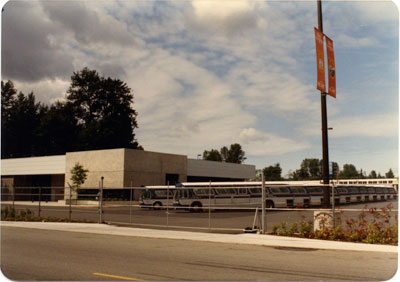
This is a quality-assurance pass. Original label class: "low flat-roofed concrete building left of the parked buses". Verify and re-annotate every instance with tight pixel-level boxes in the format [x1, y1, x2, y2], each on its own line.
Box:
[1, 149, 256, 201]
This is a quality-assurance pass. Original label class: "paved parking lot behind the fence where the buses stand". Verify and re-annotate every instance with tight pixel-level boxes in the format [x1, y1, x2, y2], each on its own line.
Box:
[2, 200, 398, 233]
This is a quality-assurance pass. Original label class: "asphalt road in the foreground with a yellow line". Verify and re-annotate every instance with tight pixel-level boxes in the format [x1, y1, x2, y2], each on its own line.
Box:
[1, 226, 397, 281]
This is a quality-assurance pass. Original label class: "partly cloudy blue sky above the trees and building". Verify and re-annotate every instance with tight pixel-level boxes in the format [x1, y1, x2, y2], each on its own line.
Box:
[1, 0, 399, 176]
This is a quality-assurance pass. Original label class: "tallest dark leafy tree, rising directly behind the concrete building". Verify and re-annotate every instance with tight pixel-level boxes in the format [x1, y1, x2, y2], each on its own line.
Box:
[66, 68, 138, 150]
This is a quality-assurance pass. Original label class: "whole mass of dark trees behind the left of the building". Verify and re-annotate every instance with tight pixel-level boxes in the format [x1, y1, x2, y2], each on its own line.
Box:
[1, 68, 143, 159]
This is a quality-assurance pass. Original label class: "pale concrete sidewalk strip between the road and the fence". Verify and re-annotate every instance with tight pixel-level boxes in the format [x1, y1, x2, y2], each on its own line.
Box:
[1, 221, 398, 253]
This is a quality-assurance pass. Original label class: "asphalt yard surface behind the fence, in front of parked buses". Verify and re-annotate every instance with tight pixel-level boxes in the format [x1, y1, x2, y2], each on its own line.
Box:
[5, 201, 398, 233]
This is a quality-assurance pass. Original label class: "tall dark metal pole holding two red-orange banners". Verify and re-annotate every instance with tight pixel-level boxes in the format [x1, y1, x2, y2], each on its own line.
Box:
[317, 0, 329, 208]
